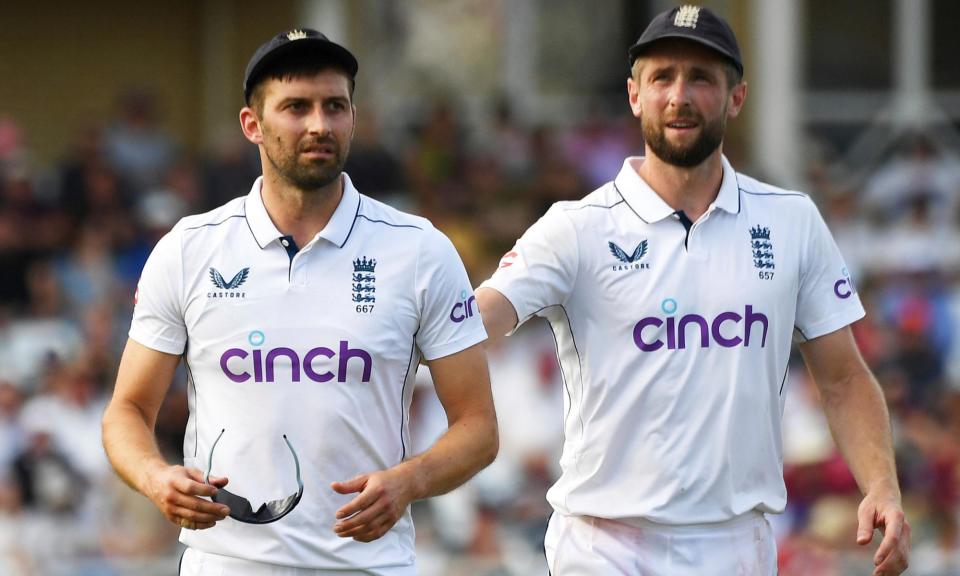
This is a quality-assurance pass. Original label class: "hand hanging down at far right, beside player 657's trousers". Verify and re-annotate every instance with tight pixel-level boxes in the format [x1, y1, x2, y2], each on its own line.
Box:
[857, 488, 910, 576]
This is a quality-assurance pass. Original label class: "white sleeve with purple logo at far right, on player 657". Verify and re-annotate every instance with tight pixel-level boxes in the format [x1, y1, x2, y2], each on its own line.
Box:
[796, 202, 865, 341]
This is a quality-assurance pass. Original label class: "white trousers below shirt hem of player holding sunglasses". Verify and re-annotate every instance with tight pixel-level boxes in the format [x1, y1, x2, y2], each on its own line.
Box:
[180, 548, 417, 576]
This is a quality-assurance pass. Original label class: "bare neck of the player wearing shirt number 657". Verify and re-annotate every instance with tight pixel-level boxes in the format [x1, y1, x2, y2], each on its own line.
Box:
[637, 148, 723, 221]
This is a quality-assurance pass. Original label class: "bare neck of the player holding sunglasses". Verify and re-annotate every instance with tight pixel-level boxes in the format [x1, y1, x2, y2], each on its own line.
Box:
[260, 166, 344, 247]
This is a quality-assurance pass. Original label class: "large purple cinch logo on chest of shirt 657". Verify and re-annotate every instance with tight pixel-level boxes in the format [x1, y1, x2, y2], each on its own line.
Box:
[633, 298, 770, 352]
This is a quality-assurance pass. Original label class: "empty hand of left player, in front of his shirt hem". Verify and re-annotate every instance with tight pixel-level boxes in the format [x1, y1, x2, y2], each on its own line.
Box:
[330, 464, 415, 542]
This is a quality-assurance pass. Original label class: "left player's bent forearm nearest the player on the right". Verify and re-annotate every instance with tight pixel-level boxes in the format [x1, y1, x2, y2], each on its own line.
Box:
[397, 413, 499, 500]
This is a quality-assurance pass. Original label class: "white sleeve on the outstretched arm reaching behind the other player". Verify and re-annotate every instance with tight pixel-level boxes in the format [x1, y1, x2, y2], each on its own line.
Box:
[481, 204, 579, 326]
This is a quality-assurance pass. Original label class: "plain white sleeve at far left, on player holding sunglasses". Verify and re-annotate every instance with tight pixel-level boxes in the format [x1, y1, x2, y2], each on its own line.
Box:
[130, 229, 187, 354]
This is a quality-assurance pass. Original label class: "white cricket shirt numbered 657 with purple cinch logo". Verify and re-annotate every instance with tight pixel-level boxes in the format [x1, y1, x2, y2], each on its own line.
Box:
[483, 158, 864, 524]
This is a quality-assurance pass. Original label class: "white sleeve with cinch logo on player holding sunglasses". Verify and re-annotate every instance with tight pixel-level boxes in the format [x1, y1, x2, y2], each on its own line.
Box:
[416, 228, 487, 360]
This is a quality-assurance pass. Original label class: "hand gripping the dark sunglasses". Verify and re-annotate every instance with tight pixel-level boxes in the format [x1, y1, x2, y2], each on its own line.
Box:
[145, 466, 230, 530]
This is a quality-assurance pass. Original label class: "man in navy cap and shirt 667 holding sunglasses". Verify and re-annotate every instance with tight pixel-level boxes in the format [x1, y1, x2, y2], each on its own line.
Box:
[103, 29, 497, 576]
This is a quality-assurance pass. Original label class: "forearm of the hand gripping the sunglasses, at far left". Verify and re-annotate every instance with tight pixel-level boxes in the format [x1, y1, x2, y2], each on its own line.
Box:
[103, 401, 167, 495]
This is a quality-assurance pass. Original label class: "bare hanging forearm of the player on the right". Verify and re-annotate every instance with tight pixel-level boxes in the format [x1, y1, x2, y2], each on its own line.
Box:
[821, 369, 900, 495]
